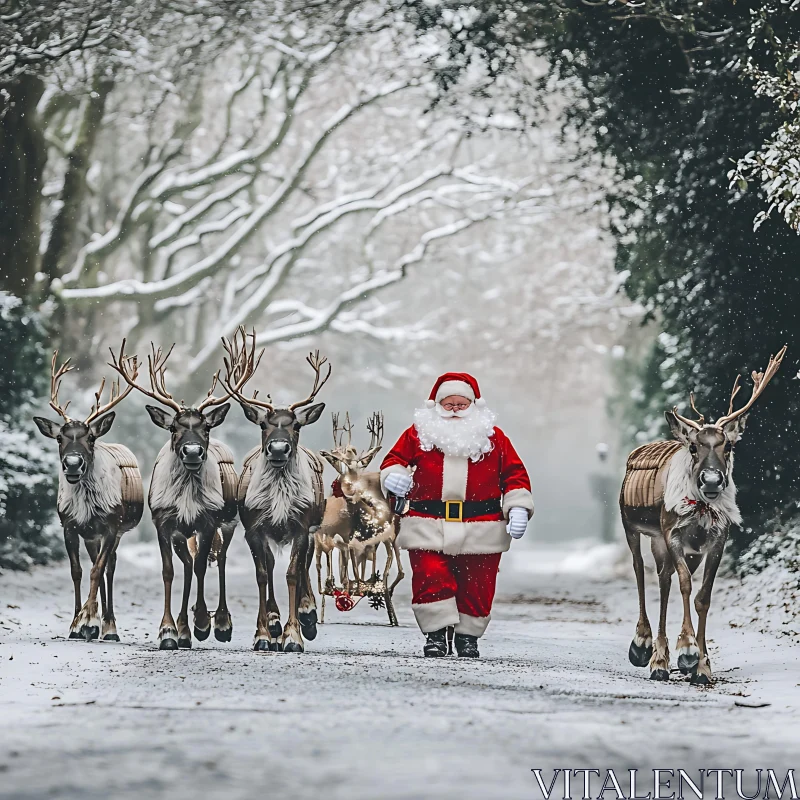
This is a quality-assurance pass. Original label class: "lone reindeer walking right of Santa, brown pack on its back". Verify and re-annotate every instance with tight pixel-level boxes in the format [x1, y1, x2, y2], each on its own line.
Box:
[620, 347, 786, 685]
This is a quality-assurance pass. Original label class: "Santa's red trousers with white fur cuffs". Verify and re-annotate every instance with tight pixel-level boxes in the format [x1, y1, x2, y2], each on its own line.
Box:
[408, 550, 502, 636]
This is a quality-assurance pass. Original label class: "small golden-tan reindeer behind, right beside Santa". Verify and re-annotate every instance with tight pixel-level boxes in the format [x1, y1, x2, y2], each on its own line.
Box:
[315, 413, 405, 618]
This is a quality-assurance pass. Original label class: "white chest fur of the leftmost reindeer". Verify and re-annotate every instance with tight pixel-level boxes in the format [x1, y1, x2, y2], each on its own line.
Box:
[58, 442, 122, 525]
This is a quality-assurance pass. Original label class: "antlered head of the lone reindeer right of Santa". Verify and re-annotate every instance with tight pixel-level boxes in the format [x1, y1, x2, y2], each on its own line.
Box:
[665, 347, 786, 500]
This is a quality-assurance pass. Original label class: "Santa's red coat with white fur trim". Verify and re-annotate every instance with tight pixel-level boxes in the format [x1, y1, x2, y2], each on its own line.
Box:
[381, 426, 533, 555]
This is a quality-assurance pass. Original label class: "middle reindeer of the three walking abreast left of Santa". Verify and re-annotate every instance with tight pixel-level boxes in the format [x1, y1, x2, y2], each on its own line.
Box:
[111, 328, 255, 650]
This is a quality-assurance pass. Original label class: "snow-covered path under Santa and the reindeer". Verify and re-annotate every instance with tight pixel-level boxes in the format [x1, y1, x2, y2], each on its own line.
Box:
[0, 537, 800, 800]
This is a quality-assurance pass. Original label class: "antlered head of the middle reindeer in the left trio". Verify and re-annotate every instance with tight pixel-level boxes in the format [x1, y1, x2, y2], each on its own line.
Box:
[110, 328, 255, 472]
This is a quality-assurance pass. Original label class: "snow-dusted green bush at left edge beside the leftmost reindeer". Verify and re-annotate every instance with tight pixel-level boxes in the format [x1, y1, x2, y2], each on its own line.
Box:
[0, 292, 63, 569]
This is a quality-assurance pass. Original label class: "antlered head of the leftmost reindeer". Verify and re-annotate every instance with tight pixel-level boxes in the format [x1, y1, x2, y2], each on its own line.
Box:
[33, 350, 139, 483]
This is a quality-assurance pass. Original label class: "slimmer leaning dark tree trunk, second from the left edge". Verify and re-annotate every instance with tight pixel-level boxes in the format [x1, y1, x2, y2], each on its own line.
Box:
[41, 72, 114, 281]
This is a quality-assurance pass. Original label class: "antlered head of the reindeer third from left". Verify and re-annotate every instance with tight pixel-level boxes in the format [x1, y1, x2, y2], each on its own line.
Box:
[225, 346, 331, 469]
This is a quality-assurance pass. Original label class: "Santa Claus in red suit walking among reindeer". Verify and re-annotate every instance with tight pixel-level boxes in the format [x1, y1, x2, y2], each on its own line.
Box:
[381, 372, 533, 658]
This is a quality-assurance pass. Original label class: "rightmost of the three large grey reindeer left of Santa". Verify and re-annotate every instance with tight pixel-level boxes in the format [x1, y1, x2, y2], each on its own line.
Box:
[228, 351, 331, 653]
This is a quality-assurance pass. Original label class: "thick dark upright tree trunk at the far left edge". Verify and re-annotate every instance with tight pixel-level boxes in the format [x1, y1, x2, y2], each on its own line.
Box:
[0, 75, 47, 297]
